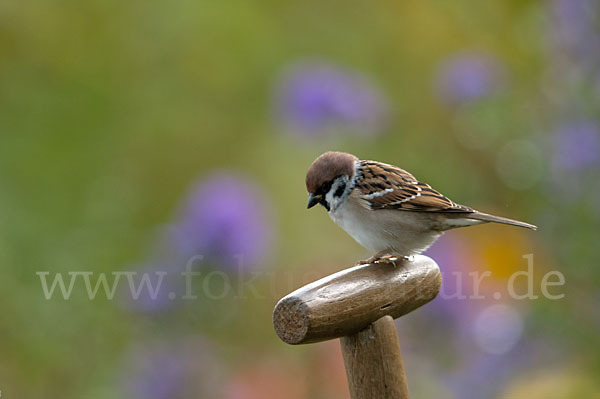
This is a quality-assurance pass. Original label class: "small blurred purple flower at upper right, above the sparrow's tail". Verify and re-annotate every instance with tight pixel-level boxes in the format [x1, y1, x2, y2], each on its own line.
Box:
[436, 53, 504, 104]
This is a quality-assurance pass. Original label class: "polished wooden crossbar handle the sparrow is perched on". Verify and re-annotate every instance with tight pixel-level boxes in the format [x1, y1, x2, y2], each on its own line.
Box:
[273, 255, 442, 344]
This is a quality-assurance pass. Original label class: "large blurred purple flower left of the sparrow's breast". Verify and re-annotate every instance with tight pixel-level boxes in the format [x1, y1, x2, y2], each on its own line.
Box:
[172, 172, 272, 269]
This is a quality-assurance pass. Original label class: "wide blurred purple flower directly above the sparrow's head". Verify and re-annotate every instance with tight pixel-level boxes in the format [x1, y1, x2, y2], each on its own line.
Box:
[275, 62, 387, 138]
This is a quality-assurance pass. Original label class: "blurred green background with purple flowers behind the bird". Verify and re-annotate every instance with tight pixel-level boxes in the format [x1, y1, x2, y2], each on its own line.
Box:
[0, 0, 600, 399]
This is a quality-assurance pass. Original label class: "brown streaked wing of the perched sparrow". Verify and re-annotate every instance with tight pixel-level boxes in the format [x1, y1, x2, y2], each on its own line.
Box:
[356, 161, 473, 212]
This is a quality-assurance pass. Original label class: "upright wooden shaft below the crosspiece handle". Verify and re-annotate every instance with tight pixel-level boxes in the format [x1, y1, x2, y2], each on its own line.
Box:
[340, 316, 408, 399]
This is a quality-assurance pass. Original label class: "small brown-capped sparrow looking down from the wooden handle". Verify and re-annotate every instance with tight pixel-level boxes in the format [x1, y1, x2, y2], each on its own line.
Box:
[306, 151, 537, 264]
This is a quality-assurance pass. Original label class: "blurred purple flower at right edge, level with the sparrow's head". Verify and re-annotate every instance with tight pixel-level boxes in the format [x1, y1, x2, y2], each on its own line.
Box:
[553, 120, 600, 171]
